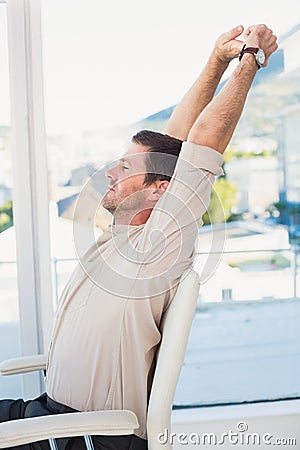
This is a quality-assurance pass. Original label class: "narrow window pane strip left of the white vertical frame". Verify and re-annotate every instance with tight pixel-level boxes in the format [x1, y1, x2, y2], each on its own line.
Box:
[0, 4, 21, 398]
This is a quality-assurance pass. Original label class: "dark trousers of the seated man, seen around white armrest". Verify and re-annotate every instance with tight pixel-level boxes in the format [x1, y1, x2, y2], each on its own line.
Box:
[0, 394, 147, 450]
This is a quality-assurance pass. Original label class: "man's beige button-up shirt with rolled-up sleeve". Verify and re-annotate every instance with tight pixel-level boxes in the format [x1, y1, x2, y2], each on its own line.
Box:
[47, 143, 223, 439]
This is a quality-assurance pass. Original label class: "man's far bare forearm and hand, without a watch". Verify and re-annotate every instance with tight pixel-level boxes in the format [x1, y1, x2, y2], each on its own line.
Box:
[164, 25, 244, 141]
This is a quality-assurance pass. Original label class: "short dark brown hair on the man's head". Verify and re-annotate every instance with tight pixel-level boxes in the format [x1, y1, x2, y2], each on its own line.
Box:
[131, 130, 183, 186]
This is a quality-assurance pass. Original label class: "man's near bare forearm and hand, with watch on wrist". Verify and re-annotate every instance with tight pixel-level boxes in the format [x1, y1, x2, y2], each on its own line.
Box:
[187, 25, 278, 153]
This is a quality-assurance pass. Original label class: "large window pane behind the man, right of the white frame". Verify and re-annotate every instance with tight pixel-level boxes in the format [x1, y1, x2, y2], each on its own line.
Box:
[42, 0, 300, 412]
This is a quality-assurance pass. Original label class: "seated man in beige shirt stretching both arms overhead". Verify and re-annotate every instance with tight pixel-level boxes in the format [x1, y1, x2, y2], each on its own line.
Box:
[0, 25, 277, 450]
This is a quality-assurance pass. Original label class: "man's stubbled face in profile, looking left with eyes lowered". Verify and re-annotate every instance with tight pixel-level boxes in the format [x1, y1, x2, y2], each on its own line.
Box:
[102, 143, 148, 214]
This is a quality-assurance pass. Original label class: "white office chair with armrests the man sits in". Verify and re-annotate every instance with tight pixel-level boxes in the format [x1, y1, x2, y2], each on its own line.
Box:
[0, 270, 199, 450]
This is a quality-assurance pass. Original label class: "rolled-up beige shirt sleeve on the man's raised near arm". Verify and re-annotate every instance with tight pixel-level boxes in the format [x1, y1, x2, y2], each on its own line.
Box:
[135, 142, 223, 278]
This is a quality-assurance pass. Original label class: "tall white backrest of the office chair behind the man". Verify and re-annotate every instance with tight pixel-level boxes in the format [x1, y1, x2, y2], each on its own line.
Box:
[147, 269, 199, 450]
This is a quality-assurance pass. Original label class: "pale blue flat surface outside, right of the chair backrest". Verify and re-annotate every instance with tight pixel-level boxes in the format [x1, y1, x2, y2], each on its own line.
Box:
[175, 294, 300, 406]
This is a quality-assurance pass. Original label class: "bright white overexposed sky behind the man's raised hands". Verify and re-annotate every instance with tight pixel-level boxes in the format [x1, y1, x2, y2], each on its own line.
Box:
[0, 0, 300, 133]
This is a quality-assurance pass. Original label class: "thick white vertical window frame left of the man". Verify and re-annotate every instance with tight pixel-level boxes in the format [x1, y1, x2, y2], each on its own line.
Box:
[6, 0, 54, 398]
